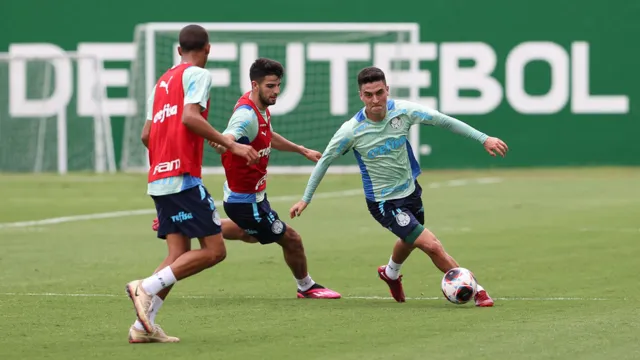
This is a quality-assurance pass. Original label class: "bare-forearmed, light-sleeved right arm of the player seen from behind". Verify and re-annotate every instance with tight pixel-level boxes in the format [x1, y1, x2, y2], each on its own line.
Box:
[182, 67, 258, 162]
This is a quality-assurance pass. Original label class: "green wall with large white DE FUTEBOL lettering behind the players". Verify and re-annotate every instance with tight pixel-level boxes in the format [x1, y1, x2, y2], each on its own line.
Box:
[0, 0, 640, 172]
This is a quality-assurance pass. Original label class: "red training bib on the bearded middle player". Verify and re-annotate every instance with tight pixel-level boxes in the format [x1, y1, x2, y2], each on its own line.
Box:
[222, 92, 271, 194]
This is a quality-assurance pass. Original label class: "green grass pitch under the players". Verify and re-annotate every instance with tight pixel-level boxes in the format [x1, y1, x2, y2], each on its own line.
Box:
[0, 168, 640, 360]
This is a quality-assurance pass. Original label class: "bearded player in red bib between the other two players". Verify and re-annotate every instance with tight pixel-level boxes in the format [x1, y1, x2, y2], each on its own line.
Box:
[211, 58, 340, 299]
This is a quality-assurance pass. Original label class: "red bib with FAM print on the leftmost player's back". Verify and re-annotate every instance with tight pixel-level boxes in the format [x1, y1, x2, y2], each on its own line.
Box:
[148, 64, 209, 182]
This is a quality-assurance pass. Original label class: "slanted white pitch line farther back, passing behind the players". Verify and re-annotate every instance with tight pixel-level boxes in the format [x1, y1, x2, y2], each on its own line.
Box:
[0, 178, 502, 229]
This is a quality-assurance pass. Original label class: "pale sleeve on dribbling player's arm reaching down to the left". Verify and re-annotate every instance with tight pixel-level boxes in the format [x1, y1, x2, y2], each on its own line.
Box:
[302, 121, 353, 204]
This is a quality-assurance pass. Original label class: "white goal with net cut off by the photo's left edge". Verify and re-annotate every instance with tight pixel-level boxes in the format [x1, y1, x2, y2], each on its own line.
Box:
[0, 50, 116, 174]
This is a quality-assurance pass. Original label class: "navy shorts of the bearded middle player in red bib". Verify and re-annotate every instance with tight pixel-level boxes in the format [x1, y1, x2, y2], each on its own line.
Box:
[223, 195, 287, 245]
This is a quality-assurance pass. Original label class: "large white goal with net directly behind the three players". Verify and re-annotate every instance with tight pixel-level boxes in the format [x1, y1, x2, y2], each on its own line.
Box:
[121, 23, 420, 173]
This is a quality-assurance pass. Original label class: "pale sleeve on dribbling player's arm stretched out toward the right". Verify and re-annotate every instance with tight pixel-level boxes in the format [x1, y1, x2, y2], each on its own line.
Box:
[405, 102, 488, 143]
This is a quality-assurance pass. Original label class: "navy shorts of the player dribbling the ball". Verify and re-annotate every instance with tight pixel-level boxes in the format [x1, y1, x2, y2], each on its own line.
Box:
[367, 181, 424, 242]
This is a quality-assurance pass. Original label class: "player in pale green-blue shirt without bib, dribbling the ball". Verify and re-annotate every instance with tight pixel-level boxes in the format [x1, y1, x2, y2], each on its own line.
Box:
[289, 67, 508, 307]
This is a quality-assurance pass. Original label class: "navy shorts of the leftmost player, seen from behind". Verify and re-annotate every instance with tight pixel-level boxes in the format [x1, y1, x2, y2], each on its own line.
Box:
[151, 185, 222, 239]
